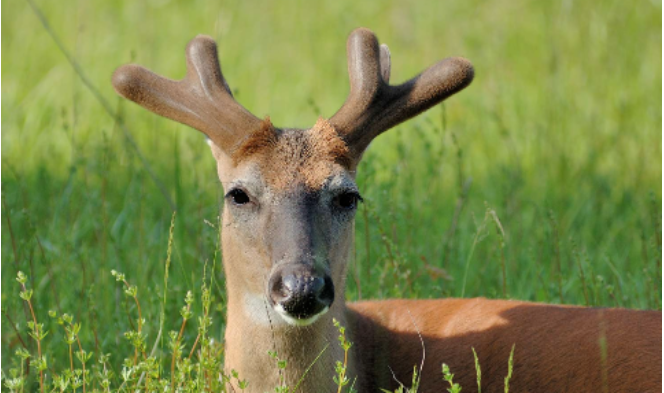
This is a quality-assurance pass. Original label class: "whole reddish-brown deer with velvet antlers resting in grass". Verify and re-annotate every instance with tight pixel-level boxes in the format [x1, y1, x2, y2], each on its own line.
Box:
[112, 28, 662, 392]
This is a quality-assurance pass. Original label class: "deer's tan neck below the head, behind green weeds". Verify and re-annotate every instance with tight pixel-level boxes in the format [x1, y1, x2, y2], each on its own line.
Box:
[222, 233, 357, 392]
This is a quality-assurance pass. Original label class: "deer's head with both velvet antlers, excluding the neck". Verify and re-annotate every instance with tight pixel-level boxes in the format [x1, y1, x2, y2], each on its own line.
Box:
[113, 28, 473, 325]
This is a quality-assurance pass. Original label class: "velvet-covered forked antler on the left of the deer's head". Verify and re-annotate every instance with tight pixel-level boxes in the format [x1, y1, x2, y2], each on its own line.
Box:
[113, 35, 261, 153]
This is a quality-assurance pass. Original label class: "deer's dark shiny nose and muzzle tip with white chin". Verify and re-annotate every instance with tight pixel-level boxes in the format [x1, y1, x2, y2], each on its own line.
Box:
[268, 265, 334, 325]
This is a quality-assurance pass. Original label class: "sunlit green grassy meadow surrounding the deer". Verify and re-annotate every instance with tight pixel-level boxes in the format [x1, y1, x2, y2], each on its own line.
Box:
[1, 0, 662, 391]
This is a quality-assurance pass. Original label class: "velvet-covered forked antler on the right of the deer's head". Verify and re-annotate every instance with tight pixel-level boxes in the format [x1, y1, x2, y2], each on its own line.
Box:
[330, 28, 474, 159]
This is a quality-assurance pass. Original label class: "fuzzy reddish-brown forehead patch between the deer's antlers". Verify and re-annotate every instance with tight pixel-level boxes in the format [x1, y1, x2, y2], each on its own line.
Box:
[232, 118, 352, 189]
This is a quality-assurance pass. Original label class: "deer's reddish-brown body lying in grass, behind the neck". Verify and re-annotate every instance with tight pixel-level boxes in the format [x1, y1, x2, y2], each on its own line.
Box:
[349, 298, 662, 393]
